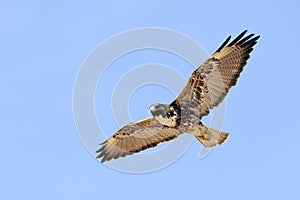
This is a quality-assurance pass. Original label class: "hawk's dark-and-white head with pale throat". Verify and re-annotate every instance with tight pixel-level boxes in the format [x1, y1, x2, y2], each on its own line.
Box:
[149, 103, 180, 127]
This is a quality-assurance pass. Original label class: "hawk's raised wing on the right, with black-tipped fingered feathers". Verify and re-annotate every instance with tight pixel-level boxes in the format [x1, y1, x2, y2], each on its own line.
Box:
[175, 31, 259, 118]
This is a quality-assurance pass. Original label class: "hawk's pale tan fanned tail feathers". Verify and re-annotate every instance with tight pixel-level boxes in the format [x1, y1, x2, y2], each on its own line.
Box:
[193, 125, 229, 147]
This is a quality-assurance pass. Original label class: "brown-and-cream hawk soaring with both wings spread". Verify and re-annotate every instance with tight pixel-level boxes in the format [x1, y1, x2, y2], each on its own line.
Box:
[96, 30, 260, 162]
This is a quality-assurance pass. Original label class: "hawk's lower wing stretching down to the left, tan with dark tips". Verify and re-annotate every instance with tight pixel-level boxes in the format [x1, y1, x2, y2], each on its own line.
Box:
[96, 117, 180, 162]
